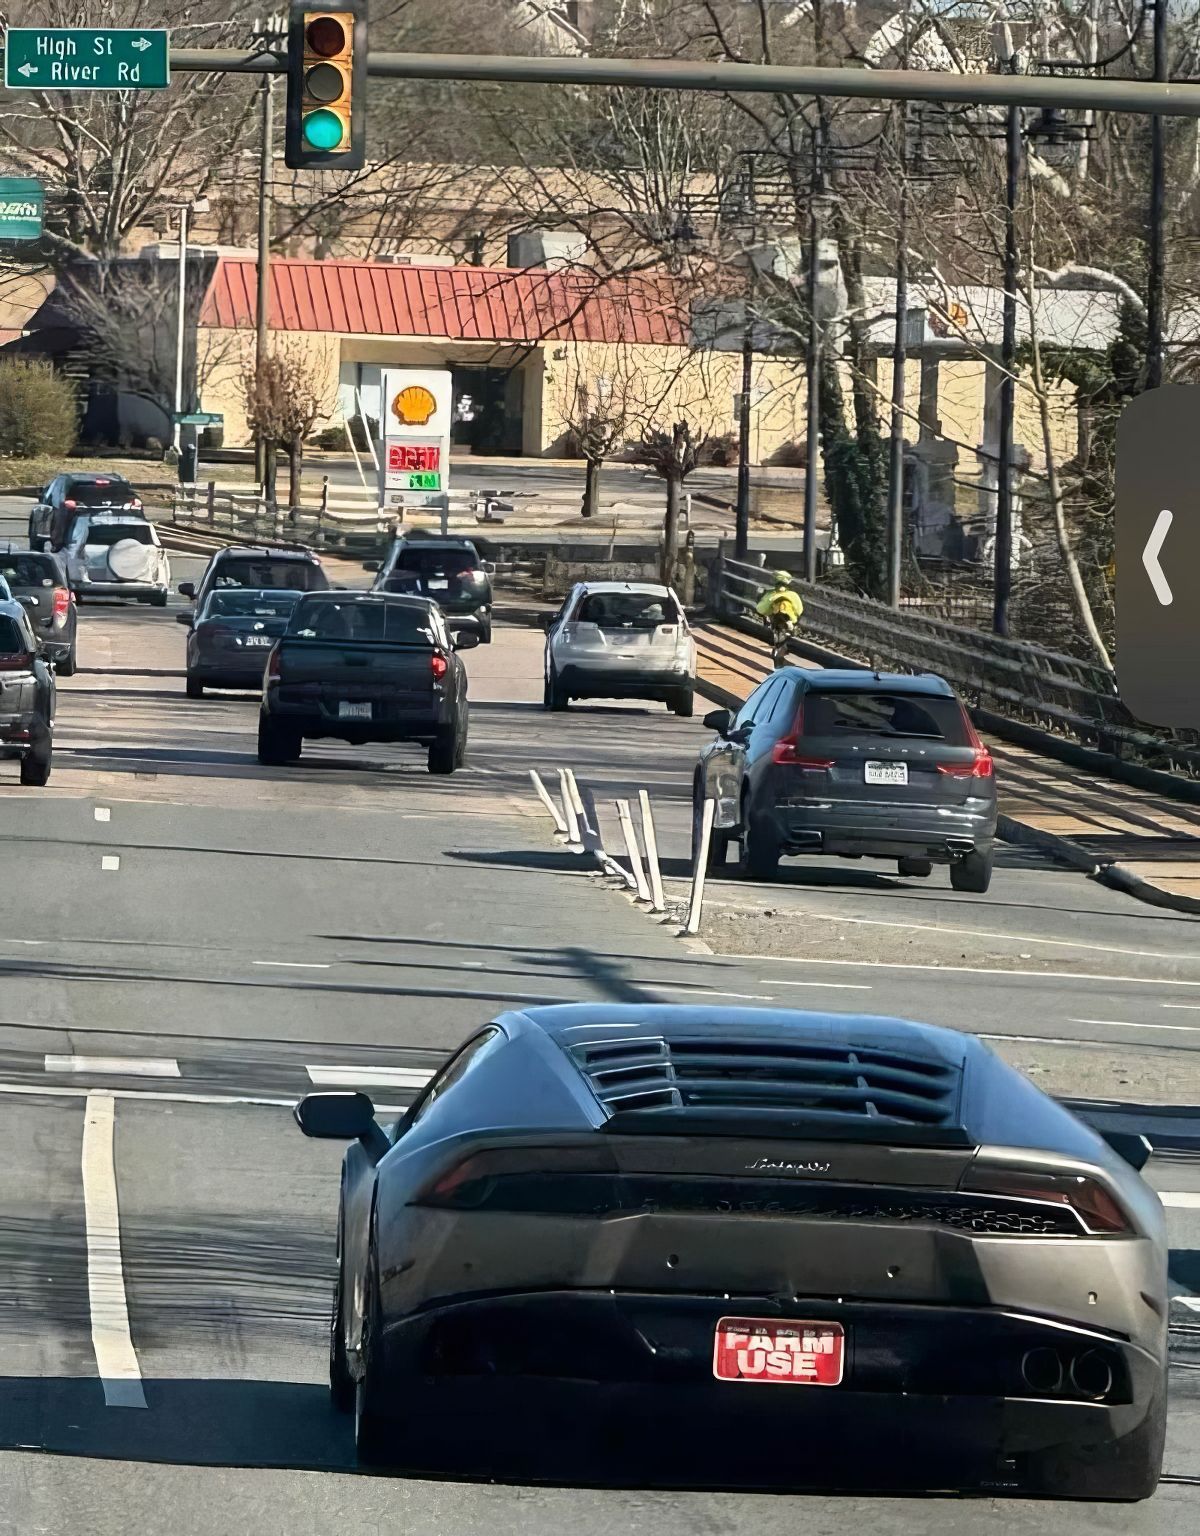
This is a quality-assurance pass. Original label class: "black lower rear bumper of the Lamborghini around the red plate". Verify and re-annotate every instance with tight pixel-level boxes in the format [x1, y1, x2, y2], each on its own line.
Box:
[383, 1292, 1163, 1482]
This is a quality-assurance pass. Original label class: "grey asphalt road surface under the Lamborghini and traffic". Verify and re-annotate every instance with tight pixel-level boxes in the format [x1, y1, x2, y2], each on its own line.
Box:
[0, 504, 1200, 1536]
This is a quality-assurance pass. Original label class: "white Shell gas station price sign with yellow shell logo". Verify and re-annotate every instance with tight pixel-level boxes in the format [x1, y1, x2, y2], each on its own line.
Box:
[380, 369, 452, 507]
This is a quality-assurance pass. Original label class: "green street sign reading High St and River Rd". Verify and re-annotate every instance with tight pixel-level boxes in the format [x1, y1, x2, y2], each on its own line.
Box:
[5, 26, 171, 91]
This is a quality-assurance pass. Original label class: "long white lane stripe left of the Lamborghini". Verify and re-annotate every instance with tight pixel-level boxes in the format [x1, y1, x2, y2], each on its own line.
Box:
[81, 1094, 146, 1409]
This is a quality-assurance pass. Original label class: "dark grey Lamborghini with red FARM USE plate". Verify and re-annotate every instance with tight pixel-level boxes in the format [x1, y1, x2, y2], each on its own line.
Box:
[297, 1003, 1166, 1499]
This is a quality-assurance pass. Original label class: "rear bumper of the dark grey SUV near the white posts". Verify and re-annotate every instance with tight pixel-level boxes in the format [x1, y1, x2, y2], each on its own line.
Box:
[765, 799, 996, 863]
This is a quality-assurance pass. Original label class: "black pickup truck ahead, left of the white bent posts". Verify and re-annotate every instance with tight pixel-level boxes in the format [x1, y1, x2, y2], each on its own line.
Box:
[258, 590, 479, 773]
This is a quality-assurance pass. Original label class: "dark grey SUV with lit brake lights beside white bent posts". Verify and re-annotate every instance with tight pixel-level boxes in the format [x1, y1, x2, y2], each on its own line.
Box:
[693, 667, 996, 892]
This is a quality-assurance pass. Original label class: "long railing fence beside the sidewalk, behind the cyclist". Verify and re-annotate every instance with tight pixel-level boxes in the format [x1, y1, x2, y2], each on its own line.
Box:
[713, 559, 1200, 779]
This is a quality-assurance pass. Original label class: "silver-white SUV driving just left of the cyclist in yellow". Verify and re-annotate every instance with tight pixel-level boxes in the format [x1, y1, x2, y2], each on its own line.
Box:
[542, 581, 696, 716]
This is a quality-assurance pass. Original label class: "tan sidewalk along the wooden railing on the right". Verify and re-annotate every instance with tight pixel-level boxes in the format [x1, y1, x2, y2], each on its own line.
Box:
[694, 624, 1200, 914]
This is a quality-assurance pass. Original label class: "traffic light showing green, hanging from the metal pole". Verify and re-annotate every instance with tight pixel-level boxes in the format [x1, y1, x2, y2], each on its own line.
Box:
[283, 0, 367, 170]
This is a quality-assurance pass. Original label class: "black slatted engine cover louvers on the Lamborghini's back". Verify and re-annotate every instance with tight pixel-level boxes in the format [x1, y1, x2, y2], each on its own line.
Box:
[570, 1037, 965, 1141]
